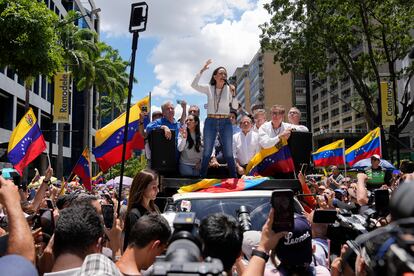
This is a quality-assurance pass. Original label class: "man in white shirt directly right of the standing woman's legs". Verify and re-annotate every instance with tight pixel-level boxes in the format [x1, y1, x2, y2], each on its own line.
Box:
[233, 116, 260, 175]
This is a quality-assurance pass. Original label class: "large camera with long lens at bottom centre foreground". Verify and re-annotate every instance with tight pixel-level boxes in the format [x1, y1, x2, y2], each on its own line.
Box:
[152, 212, 223, 275]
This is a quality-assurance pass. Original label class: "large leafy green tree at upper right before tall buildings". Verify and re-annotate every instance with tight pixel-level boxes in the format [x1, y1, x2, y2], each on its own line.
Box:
[261, 0, 414, 133]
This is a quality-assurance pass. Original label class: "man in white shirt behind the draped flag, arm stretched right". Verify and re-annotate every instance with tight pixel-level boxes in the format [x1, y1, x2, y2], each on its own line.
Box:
[259, 104, 308, 149]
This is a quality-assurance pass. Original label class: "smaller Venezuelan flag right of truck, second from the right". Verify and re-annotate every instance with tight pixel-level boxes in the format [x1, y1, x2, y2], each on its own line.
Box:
[312, 139, 345, 167]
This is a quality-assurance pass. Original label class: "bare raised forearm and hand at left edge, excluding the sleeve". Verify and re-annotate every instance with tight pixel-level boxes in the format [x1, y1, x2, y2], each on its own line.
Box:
[0, 176, 35, 262]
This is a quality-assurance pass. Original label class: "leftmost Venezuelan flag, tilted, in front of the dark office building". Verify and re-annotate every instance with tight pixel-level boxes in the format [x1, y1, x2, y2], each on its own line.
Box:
[7, 108, 46, 175]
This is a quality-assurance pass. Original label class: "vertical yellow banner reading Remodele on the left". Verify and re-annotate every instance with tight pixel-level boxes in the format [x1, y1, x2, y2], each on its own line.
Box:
[53, 72, 71, 123]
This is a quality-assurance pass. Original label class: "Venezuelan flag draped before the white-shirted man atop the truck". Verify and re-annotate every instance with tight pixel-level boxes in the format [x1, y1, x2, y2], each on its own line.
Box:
[246, 139, 295, 176]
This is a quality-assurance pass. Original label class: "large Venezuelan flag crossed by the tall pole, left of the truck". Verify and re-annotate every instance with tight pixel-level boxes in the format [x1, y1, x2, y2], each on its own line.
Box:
[93, 96, 149, 172]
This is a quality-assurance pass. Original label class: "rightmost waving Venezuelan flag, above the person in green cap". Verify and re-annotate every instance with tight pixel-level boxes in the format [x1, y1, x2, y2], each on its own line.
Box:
[345, 127, 381, 166]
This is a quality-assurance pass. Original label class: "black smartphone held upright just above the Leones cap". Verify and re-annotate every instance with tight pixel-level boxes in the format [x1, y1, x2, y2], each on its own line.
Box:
[271, 189, 294, 233]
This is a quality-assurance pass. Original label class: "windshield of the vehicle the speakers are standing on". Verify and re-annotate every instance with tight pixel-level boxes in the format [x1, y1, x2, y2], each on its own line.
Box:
[175, 196, 301, 231]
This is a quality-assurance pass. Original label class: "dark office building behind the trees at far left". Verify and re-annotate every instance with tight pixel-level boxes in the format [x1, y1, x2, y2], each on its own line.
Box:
[0, 0, 99, 180]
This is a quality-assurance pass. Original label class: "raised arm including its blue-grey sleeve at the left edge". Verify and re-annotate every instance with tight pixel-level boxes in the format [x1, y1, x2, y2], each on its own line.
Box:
[0, 176, 37, 275]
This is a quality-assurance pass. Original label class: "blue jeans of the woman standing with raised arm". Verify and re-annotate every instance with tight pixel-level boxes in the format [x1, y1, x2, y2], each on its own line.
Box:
[200, 118, 237, 178]
